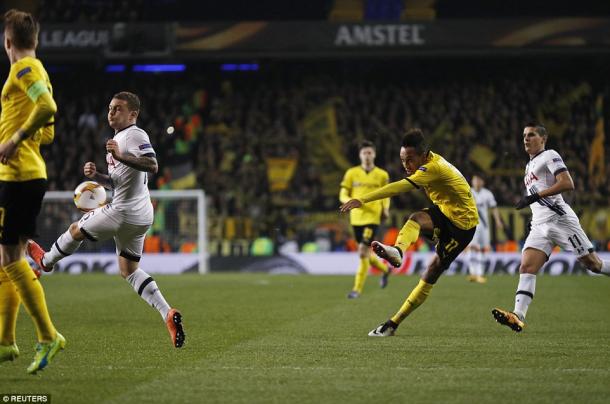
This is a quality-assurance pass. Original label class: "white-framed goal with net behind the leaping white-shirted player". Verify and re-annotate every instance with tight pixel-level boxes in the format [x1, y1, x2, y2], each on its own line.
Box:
[36, 190, 208, 274]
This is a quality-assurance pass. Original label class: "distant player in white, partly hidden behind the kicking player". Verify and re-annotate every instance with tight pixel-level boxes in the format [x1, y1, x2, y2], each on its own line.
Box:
[468, 175, 504, 283]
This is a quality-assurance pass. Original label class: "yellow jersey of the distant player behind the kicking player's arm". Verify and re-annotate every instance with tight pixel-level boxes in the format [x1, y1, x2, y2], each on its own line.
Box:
[339, 166, 390, 226]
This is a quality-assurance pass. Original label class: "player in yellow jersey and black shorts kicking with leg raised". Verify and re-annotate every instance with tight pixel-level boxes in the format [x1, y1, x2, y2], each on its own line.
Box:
[341, 129, 479, 337]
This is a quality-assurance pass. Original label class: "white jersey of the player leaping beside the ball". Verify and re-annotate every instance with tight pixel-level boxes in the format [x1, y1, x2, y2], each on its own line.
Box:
[106, 125, 155, 225]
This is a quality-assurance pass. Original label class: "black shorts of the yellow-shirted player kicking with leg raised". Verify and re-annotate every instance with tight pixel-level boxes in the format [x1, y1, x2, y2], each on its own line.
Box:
[424, 205, 477, 269]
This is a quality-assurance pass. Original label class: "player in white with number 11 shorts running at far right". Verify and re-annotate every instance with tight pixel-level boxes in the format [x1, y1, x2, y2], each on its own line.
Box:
[492, 123, 610, 332]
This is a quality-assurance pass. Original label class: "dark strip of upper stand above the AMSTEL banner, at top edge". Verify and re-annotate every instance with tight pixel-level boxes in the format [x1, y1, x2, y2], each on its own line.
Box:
[27, 0, 610, 23]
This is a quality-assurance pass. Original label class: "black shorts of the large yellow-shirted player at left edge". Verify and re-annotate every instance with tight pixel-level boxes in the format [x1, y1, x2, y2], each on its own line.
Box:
[0, 179, 47, 245]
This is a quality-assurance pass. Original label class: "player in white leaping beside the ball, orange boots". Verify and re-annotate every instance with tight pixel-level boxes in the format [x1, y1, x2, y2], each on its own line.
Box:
[28, 91, 185, 348]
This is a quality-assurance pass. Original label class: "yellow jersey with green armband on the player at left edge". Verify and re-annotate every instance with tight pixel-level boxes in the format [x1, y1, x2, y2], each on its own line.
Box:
[0, 56, 54, 181]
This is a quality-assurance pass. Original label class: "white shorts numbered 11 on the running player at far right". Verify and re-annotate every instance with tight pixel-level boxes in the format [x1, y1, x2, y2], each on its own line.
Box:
[523, 215, 593, 258]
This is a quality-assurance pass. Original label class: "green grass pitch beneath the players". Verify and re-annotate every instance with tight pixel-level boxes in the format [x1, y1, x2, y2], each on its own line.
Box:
[0, 274, 610, 403]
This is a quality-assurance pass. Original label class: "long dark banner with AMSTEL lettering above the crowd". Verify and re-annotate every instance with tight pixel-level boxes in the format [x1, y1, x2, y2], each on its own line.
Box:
[175, 18, 610, 55]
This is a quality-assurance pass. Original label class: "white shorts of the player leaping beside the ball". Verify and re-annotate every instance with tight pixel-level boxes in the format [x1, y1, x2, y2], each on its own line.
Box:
[78, 204, 150, 262]
